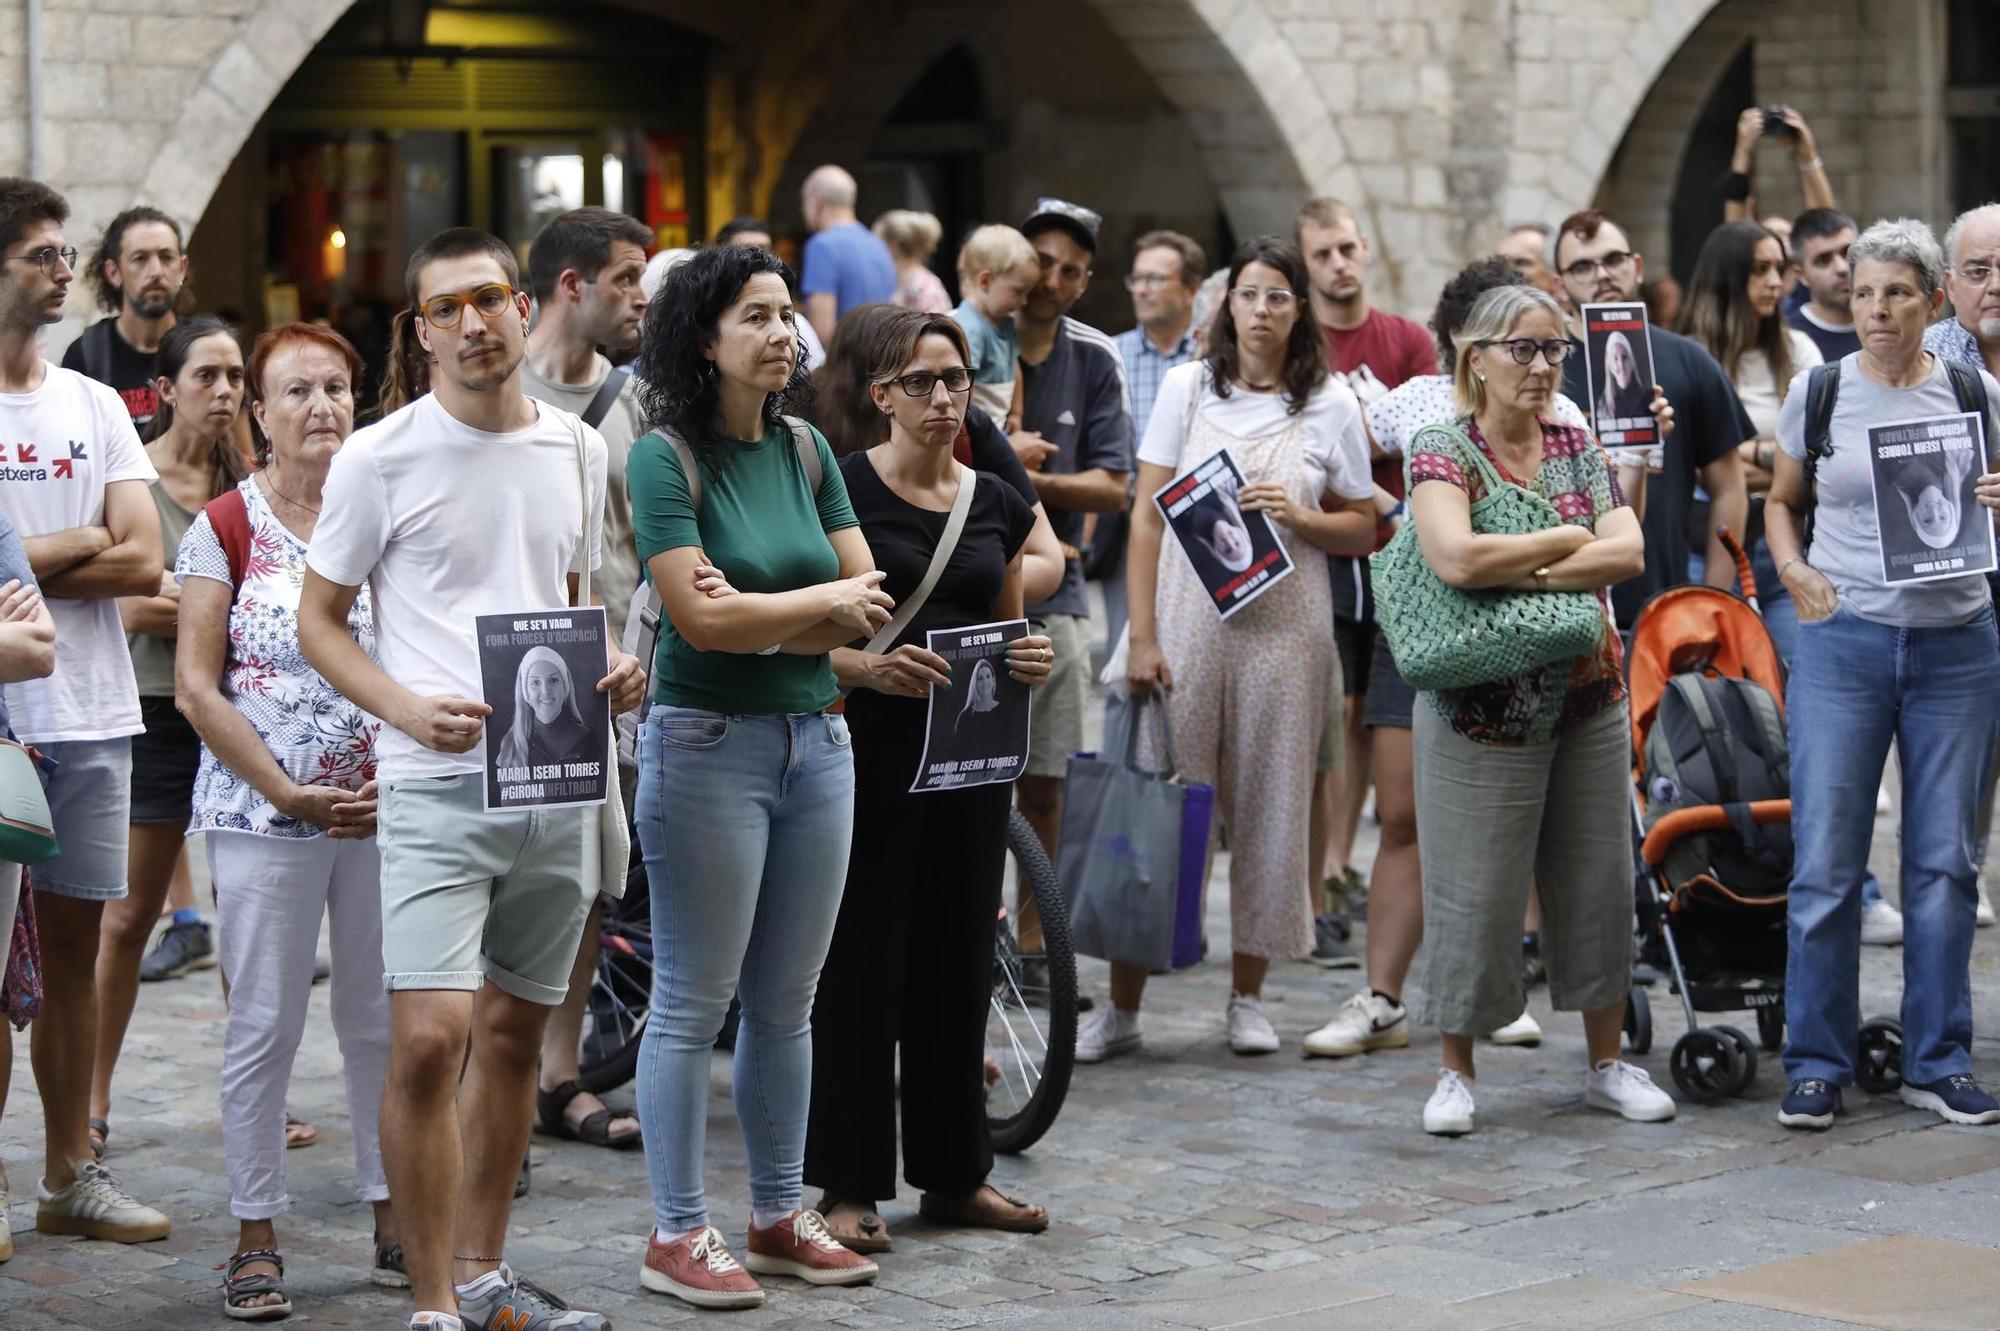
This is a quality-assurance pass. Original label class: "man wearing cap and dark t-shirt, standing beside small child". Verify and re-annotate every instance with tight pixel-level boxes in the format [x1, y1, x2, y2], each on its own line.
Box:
[1012, 198, 1132, 951]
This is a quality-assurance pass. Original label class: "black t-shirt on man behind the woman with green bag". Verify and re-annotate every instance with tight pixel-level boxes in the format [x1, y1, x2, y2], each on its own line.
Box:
[1562, 328, 1756, 626]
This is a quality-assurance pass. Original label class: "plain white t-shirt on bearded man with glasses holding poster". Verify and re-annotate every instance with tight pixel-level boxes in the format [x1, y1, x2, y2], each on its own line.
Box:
[306, 396, 606, 779]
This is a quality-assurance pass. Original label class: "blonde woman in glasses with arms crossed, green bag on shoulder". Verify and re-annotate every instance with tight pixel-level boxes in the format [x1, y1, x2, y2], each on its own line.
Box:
[1400, 286, 1674, 1135]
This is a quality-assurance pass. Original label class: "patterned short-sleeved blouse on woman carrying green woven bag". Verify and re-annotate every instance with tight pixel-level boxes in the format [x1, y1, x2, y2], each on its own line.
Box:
[1408, 418, 1626, 745]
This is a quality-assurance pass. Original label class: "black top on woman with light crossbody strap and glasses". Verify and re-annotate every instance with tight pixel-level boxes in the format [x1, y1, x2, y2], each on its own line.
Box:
[840, 450, 1034, 648]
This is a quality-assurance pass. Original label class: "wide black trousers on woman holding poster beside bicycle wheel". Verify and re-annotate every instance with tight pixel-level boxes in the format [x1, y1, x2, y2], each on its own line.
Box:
[806, 691, 1014, 1203]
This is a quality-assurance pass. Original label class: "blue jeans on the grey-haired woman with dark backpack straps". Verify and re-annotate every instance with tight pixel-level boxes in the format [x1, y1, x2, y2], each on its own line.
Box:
[1784, 606, 2000, 1085]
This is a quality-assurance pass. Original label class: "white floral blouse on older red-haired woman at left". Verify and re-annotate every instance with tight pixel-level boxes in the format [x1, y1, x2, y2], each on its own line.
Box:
[174, 476, 382, 839]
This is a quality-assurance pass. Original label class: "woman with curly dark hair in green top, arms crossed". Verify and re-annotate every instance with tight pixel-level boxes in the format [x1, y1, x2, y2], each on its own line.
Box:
[626, 246, 890, 1307]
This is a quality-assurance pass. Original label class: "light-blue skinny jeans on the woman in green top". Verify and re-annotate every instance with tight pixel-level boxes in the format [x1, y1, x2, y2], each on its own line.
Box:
[634, 703, 854, 1235]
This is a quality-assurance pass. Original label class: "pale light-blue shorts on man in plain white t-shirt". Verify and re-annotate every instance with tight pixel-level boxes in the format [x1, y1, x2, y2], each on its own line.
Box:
[376, 773, 598, 1007]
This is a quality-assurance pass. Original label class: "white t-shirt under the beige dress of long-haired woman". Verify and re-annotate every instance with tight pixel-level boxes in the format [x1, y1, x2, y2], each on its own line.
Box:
[1138, 360, 1374, 500]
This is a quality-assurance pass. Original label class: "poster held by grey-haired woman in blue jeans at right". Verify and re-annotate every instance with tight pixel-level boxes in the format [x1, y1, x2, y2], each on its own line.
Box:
[1868, 412, 1994, 586]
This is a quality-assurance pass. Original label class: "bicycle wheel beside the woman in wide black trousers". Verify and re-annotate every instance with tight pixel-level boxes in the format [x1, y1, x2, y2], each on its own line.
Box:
[986, 809, 1076, 1155]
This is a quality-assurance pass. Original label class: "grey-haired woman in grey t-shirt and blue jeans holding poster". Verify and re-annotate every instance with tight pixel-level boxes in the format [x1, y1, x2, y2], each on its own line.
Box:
[1766, 218, 2000, 1129]
